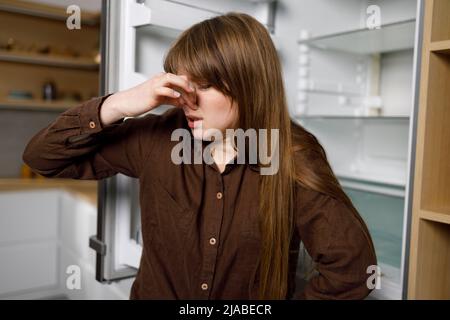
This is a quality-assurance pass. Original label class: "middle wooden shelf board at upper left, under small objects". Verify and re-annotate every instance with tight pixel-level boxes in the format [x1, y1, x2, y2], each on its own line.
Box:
[0, 51, 99, 71]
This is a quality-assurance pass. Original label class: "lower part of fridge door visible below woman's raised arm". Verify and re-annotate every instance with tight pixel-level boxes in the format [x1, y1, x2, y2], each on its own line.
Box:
[89, 174, 142, 282]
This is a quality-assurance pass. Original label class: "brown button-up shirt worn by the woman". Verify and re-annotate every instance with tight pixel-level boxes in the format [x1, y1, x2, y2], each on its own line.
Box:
[23, 96, 377, 299]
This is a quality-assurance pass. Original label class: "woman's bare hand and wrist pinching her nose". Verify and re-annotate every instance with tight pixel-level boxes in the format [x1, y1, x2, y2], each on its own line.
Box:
[100, 72, 197, 125]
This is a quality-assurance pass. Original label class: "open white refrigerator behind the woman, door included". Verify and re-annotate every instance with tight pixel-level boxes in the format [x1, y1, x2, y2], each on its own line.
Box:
[90, 0, 423, 299]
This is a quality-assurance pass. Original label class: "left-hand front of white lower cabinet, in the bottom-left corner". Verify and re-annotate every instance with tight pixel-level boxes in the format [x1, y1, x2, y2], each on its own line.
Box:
[0, 191, 59, 297]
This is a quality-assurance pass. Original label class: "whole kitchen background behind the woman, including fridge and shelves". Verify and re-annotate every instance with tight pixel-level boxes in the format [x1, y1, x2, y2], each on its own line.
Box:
[0, 0, 450, 299]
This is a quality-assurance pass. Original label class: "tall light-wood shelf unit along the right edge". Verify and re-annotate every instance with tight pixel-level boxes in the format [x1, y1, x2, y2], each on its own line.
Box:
[408, 0, 450, 299]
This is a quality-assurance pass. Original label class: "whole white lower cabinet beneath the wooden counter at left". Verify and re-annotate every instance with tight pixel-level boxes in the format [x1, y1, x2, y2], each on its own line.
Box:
[0, 189, 132, 299]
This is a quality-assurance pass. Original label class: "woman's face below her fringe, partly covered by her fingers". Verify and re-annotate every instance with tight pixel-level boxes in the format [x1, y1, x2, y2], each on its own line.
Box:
[179, 74, 238, 140]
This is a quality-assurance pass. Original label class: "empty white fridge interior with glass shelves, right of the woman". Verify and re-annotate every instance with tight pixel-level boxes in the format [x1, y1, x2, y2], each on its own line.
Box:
[292, 1, 418, 299]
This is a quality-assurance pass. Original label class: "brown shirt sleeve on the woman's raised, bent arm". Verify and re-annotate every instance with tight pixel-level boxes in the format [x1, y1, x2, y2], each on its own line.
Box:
[22, 95, 160, 180]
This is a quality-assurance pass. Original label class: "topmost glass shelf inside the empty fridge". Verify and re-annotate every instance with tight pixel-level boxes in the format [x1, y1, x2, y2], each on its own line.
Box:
[298, 19, 416, 54]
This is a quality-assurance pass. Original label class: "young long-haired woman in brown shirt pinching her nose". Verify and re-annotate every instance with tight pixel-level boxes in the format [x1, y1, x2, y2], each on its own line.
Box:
[23, 12, 377, 299]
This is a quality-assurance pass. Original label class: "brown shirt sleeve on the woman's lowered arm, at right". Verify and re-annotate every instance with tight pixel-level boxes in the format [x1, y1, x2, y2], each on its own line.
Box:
[293, 187, 377, 299]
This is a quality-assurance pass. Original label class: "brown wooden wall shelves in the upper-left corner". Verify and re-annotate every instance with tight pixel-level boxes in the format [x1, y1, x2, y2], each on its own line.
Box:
[0, 0, 100, 111]
